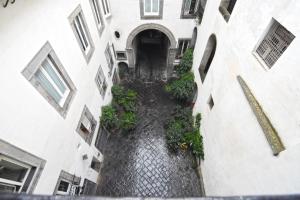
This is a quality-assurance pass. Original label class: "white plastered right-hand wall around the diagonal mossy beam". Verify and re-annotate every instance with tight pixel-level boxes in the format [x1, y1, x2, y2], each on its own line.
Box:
[193, 0, 300, 195]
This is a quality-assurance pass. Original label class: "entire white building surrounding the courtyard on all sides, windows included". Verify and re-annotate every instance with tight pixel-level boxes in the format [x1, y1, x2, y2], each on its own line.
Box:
[0, 0, 300, 195]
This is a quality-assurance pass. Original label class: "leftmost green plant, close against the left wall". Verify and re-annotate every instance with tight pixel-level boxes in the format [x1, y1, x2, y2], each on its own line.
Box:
[100, 105, 118, 131]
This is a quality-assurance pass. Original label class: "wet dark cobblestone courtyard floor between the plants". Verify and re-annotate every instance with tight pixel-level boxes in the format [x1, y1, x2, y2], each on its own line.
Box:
[97, 81, 201, 197]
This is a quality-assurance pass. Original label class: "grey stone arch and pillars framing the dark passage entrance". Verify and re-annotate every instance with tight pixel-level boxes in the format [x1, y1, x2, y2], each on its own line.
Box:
[126, 23, 177, 80]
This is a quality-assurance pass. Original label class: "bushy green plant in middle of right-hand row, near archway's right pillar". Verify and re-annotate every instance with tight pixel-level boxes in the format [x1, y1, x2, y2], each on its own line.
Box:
[165, 72, 195, 101]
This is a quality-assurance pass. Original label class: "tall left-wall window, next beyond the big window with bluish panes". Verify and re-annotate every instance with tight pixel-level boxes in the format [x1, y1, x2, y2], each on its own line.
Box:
[69, 5, 94, 62]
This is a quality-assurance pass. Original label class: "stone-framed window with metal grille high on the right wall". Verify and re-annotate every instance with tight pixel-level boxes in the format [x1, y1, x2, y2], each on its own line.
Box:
[254, 19, 295, 68]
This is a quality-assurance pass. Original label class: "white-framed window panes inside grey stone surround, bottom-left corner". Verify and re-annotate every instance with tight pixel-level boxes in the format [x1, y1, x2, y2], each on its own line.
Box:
[0, 154, 31, 192]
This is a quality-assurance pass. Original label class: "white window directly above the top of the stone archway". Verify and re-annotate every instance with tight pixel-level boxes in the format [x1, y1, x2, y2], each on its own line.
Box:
[140, 0, 163, 19]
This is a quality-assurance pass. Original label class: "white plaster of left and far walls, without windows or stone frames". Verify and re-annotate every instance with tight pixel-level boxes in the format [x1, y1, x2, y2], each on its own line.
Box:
[0, 0, 195, 194]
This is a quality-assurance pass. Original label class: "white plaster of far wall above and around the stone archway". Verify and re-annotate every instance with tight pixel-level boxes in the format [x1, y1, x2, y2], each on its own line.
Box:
[110, 0, 196, 51]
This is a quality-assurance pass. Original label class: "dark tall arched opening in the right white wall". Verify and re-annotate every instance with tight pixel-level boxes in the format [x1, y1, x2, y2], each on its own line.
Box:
[199, 34, 217, 83]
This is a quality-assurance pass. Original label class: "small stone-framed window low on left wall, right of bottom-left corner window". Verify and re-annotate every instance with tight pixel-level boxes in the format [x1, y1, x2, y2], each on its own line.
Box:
[54, 170, 81, 196]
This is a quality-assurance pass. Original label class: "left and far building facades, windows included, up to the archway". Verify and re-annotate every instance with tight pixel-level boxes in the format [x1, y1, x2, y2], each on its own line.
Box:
[0, 0, 195, 195]
